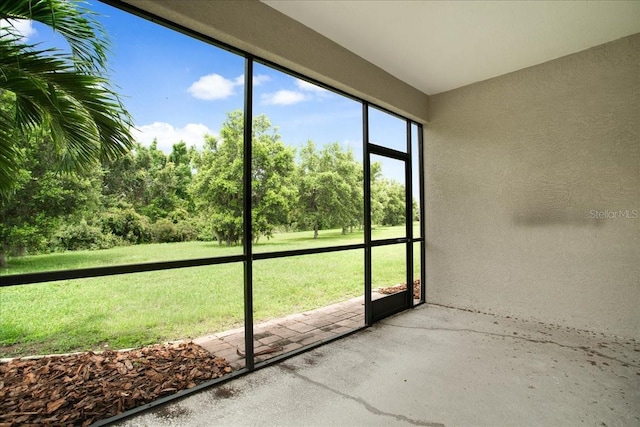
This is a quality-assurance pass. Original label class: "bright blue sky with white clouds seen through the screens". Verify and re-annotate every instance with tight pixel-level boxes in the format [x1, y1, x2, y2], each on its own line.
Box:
[13, 1, 420, 189]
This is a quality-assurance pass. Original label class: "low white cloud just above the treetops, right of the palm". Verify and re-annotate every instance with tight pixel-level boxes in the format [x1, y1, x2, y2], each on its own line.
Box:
[132, 122, 215, 154]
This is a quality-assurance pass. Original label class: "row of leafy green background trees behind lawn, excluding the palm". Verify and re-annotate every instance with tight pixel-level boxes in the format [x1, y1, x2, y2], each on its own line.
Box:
[0, 110, 412, 264]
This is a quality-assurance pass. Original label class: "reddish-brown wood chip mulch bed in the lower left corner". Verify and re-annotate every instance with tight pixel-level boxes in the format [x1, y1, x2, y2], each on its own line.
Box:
[0, 342, 232, 427]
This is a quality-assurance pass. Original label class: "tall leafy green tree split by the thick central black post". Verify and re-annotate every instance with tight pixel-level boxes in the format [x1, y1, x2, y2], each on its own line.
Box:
[191, 111, 295, 245]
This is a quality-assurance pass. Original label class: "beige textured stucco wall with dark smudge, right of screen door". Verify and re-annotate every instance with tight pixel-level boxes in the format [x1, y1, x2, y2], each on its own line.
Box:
[425, 34, 640, 337]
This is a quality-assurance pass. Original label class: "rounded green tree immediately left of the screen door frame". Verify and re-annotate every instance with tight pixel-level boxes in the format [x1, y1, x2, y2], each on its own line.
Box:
[298, 141, 363, 239]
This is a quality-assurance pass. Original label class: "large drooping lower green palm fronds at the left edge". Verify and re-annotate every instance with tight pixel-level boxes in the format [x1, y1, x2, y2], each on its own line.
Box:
[0, 26, 134, 197]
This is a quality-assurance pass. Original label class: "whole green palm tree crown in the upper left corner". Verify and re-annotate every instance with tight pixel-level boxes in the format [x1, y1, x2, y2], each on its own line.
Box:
[0, 0, 134, 195]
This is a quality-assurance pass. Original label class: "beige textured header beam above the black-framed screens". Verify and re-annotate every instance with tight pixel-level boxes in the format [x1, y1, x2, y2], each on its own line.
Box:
[125, 0, 428, 123]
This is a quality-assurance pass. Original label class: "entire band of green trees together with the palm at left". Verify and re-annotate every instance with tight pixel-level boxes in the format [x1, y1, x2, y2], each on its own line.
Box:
[0, 0, 415, 265]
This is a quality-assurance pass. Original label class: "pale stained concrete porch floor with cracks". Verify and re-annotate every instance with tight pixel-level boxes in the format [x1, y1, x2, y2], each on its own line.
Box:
[120, 305, 640, 426]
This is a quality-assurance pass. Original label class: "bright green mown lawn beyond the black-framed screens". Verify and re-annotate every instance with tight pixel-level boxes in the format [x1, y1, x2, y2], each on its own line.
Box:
[0, 227, 420, 357]
